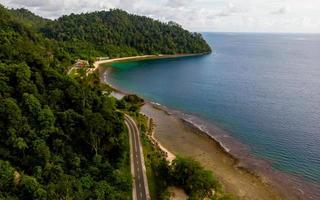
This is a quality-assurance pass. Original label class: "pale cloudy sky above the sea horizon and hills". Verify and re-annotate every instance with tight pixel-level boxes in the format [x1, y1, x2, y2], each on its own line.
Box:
[0, 0, 320, 33]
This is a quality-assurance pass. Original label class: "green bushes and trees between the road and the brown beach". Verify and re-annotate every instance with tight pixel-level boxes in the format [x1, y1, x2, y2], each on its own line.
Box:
[117, 99, 233, 200]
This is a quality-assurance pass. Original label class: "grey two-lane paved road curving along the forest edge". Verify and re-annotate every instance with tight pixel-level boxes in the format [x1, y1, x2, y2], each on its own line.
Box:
[125, 115, 150, 200]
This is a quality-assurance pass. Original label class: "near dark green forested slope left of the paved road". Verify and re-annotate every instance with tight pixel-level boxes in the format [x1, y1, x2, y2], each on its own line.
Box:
[0, 7, 131, 199]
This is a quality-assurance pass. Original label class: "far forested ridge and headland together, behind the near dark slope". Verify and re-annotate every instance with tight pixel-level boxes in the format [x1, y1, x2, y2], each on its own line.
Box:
[2, 6, 211, 65]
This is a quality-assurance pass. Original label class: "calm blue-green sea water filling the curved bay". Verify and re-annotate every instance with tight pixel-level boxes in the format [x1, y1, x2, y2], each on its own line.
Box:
[109, 33, 320, 182]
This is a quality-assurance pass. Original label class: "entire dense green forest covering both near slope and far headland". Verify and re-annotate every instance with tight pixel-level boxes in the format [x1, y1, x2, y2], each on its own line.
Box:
[0, 5, 219, 200]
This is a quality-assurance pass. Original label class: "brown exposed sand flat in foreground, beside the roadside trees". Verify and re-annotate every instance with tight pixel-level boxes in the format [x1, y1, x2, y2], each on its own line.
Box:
[142, 104, 290, 200]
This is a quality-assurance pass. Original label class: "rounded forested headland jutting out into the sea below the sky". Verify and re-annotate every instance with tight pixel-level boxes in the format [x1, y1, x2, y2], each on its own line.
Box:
[41, 9, 211, 57]
